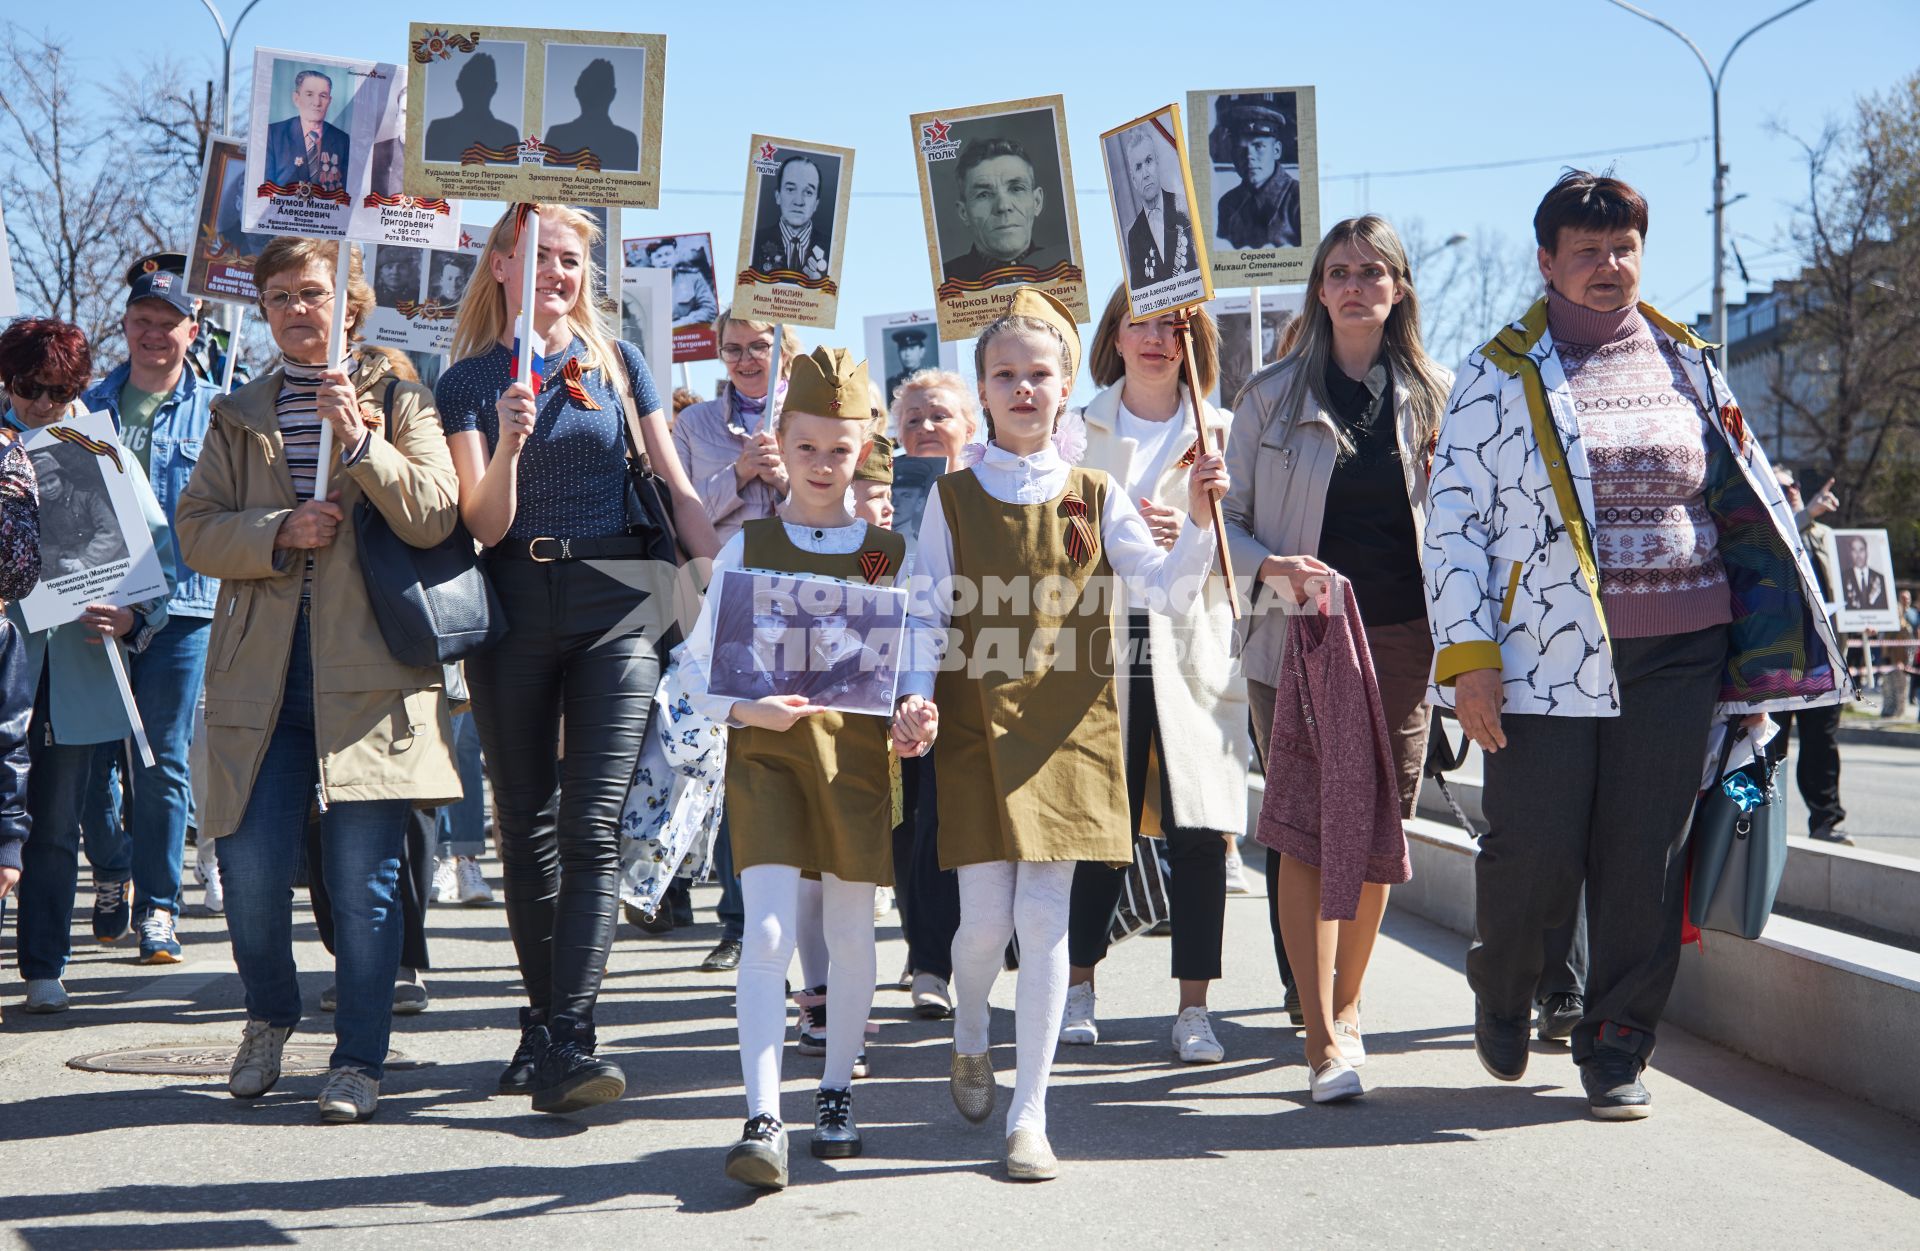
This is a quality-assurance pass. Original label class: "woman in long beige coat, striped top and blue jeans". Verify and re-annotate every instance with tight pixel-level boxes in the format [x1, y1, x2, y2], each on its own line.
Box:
[175, 238, 461, 1121]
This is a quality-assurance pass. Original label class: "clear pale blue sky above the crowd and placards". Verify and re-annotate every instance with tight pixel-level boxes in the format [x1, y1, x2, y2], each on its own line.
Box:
[33, 0, 1920, 386]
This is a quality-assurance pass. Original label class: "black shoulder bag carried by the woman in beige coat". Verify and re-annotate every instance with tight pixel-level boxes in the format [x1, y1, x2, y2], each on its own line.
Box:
[353, 382, 507, 668]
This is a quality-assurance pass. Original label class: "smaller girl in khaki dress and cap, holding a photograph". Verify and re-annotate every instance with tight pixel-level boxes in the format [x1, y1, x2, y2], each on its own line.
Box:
[687, 347, 933, 1190]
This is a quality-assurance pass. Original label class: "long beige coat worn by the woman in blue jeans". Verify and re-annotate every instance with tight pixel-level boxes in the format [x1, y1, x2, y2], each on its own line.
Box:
[175, 351, 461, 838]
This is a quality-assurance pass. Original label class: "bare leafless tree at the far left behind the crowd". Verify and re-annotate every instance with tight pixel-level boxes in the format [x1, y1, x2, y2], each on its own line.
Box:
[0, 25, 140, 343]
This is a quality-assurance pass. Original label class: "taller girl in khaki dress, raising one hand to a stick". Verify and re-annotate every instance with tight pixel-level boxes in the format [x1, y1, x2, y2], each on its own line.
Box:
[898, 288, 1227, 1180]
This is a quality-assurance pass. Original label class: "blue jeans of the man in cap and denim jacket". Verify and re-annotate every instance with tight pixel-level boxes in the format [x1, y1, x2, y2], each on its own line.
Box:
[86, 616, 213, 917]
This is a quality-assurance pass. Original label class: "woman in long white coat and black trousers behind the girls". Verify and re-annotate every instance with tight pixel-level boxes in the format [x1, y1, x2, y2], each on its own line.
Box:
[1060, 288, 1252, 1063]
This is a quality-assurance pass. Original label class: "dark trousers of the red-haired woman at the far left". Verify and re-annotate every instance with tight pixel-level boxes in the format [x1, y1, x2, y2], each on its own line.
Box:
[19, 690, 111, 980]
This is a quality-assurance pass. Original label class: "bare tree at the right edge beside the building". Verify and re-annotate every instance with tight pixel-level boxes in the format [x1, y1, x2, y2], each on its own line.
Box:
[1768, 73, 1920, 548]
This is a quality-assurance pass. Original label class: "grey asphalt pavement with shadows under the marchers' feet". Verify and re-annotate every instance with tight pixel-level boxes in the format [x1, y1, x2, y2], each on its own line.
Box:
[0, 863, 1920, 1251]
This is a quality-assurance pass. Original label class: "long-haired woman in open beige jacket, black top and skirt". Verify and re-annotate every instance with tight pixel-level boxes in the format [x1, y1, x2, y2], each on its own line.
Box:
[1225, 215, 1452, 1103]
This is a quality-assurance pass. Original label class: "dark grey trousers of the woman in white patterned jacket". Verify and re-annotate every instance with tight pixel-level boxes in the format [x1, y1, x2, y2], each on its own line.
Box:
[1467, 626, 1726, 1061]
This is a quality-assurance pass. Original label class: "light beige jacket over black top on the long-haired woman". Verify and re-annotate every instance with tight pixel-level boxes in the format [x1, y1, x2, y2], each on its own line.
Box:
[1221, 359, 1427, 687]
